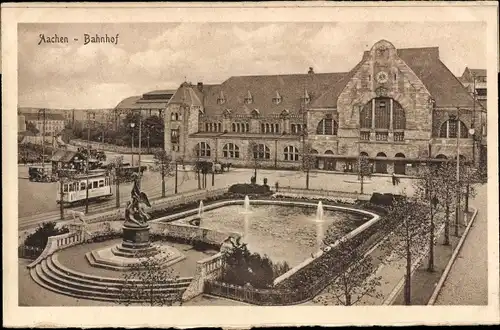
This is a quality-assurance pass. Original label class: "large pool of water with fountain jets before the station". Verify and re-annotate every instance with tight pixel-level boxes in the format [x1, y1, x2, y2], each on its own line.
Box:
[153, 200, 376, 266]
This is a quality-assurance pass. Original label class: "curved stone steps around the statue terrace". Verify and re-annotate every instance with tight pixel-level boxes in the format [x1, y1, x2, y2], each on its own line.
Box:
[30, 253, 192, 303]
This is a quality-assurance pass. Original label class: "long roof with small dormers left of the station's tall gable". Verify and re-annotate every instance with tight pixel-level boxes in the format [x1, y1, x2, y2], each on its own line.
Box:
[203, 73, 346, 115]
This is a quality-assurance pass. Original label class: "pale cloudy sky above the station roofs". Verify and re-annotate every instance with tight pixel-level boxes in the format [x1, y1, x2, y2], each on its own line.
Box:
[18, 22, 486, 109]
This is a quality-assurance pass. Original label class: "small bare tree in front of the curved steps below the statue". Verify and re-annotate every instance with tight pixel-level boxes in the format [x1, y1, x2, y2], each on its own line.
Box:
[117, 255, 182, 306]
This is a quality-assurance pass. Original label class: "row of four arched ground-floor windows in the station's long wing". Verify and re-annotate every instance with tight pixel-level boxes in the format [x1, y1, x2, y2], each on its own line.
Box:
[196, 142, 300, 161]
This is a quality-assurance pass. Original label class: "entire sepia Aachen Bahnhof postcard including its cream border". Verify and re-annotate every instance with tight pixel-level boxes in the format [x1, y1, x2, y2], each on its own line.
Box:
[2, 3, 500, 326]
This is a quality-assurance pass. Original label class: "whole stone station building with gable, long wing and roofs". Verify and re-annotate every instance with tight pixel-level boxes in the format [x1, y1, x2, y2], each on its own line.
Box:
[164, 40, 486, 174]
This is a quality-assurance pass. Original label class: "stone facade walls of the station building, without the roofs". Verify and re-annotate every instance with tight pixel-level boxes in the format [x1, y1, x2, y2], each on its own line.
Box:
[165, 41, 480, 174]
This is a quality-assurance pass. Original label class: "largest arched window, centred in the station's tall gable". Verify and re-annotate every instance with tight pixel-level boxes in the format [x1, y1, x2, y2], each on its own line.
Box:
[359, 97, 406, 130]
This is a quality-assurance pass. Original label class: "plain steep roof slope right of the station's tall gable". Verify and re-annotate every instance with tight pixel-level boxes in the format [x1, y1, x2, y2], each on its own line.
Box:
[398, 47, 479, 107]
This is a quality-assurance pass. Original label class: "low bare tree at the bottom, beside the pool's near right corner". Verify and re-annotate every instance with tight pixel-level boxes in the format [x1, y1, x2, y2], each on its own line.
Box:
[317, 229, 382, 306]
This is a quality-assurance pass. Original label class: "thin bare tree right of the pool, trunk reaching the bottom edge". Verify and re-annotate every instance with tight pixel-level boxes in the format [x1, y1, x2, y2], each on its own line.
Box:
[382, 197, 429, 305]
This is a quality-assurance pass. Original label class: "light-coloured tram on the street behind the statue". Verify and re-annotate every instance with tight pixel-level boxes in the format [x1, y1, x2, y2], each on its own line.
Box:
[56, 171, 113, 205]
